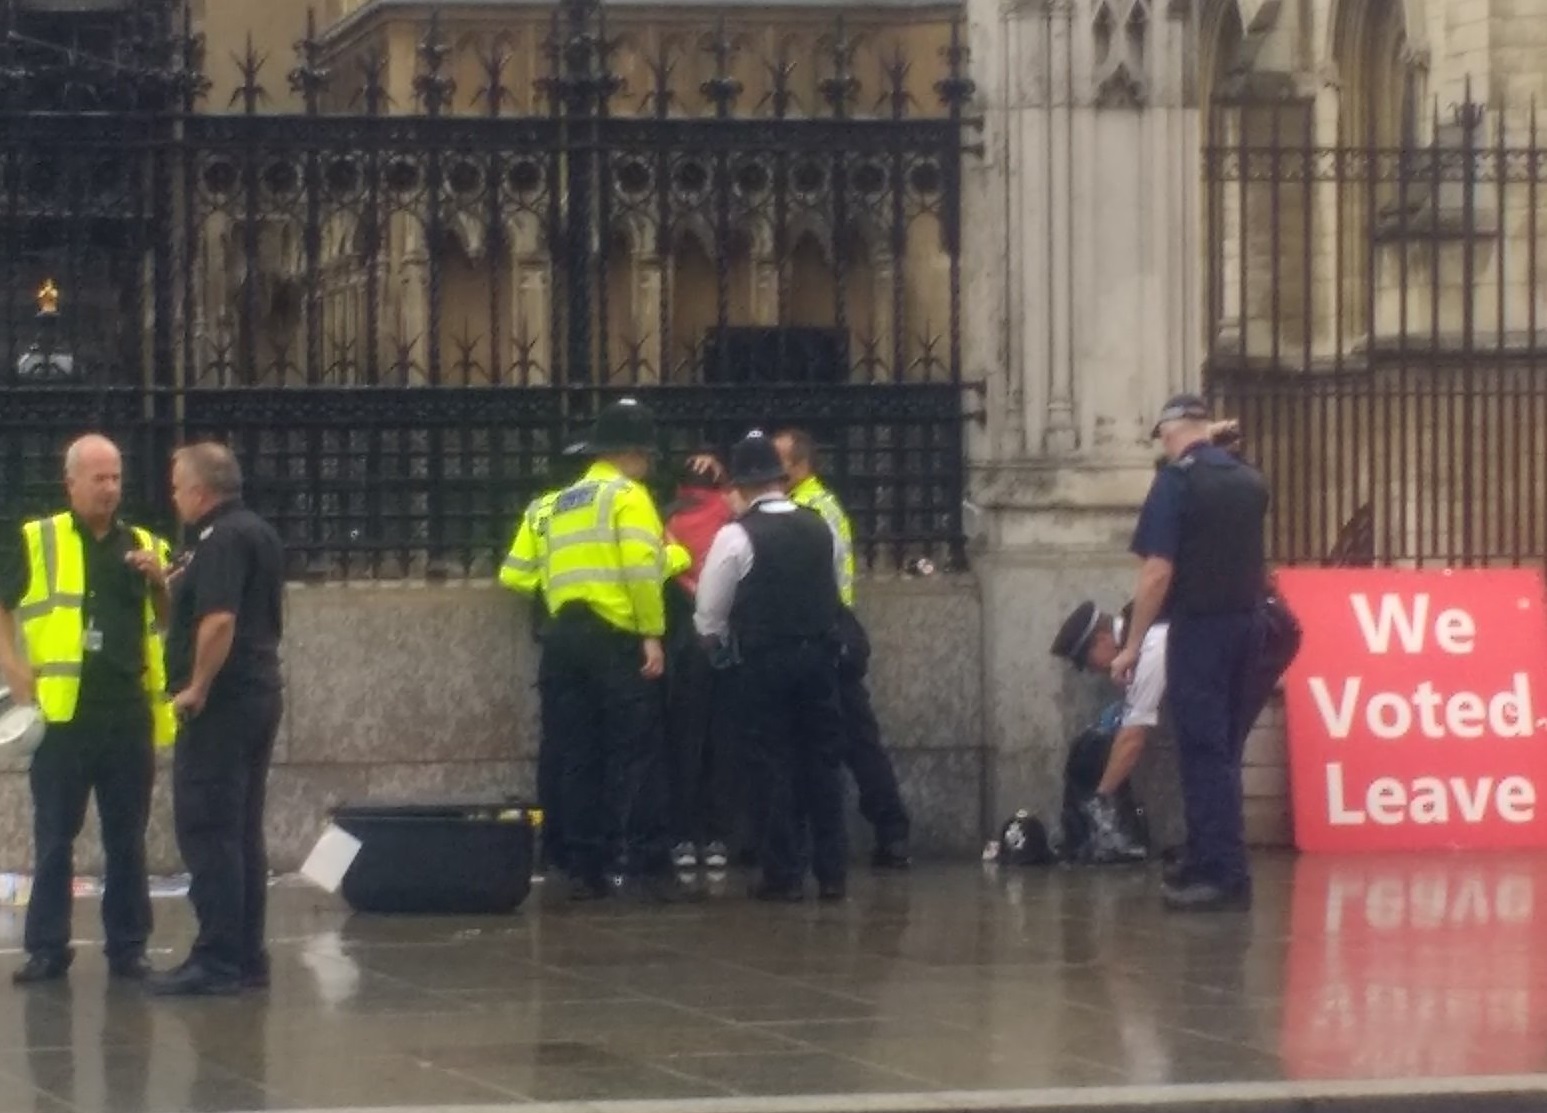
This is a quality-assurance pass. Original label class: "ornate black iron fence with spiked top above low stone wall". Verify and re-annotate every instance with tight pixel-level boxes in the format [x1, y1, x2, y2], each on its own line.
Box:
[0, 0, 972, 577]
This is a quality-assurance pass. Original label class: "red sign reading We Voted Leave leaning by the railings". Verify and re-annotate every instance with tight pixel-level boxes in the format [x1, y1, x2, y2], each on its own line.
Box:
[1278, 570, 1547, 851]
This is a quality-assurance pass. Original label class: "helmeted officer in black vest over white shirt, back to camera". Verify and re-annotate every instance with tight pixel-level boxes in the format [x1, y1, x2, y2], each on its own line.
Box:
[693, 432, 846, 901]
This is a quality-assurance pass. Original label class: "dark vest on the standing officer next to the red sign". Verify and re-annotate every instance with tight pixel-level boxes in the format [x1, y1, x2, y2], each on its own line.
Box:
[1166, 457, 1269, 615]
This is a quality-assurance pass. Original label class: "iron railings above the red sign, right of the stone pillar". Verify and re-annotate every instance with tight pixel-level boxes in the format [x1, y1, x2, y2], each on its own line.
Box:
[1207, 96, 1547, 567]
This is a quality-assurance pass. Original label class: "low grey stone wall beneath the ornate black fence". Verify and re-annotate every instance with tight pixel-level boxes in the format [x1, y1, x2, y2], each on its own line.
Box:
[0, 576, 985, 873]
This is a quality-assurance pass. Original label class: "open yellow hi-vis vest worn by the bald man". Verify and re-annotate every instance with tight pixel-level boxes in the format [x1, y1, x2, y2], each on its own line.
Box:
[15, 514, 178, 746]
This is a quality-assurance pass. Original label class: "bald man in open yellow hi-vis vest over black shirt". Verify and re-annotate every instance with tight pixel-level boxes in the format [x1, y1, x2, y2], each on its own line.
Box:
[0, 435, 176, 985]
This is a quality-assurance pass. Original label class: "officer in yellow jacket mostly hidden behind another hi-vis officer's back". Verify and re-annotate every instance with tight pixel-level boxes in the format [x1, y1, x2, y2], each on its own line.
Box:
[500, 441, 586, 872]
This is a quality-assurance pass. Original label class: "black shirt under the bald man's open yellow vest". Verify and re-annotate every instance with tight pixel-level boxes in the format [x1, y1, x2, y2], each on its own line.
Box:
[0, 515, 150, 721]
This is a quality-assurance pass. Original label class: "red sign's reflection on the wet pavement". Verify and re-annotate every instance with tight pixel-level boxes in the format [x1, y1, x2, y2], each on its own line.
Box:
[1281, 853, 1547, 1079]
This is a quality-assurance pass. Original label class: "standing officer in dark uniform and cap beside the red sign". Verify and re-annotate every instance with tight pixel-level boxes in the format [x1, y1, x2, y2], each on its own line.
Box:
[1112, 395, 1269, 912]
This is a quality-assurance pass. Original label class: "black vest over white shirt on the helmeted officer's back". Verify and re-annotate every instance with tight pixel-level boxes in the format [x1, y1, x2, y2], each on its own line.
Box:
[730, 506, 842, 647]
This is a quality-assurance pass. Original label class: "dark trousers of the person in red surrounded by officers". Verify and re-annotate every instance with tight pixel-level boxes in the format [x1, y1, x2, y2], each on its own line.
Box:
[667, 633, 741, 847]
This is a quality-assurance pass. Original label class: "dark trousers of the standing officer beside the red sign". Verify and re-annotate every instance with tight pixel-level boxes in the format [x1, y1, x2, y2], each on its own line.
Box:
[1166, 611, 1261, 889]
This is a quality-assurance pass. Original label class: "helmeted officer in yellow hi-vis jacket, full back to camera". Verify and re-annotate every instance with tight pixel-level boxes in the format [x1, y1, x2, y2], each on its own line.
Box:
[540, 398, 696, 899]
